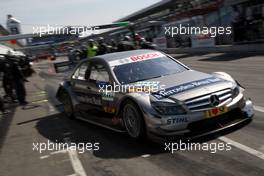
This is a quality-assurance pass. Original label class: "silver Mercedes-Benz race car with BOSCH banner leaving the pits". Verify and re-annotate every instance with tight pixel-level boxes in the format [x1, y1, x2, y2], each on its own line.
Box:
[56, 50, 254, 138]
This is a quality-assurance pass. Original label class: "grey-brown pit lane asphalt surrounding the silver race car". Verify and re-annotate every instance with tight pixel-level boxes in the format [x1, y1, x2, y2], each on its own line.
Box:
[0, 53, 264, 176]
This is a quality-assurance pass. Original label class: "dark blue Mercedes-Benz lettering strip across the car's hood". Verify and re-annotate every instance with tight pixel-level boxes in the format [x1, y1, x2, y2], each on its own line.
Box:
[152, 77, 225, 99]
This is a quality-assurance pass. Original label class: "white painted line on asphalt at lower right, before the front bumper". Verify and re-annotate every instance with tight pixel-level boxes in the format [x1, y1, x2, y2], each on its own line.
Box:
[218, 136, 264, 160]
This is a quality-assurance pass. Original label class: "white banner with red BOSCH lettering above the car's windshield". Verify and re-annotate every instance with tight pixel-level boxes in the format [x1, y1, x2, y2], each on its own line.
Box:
[109, 52, 164, 66]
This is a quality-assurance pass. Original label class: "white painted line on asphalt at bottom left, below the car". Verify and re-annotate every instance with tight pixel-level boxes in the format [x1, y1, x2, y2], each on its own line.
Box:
[64, 137, 86, 176]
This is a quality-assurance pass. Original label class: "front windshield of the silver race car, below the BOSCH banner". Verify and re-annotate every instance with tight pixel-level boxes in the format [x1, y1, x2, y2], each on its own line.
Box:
[113, 56, 187, 84]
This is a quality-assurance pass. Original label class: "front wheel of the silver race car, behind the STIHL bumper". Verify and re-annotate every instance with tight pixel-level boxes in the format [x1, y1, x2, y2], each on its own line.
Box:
[122, 100, 146, 139]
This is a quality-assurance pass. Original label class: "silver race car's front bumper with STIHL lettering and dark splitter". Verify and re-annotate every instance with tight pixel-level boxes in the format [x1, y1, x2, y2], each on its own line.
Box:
[145, 94, 254, 140]
